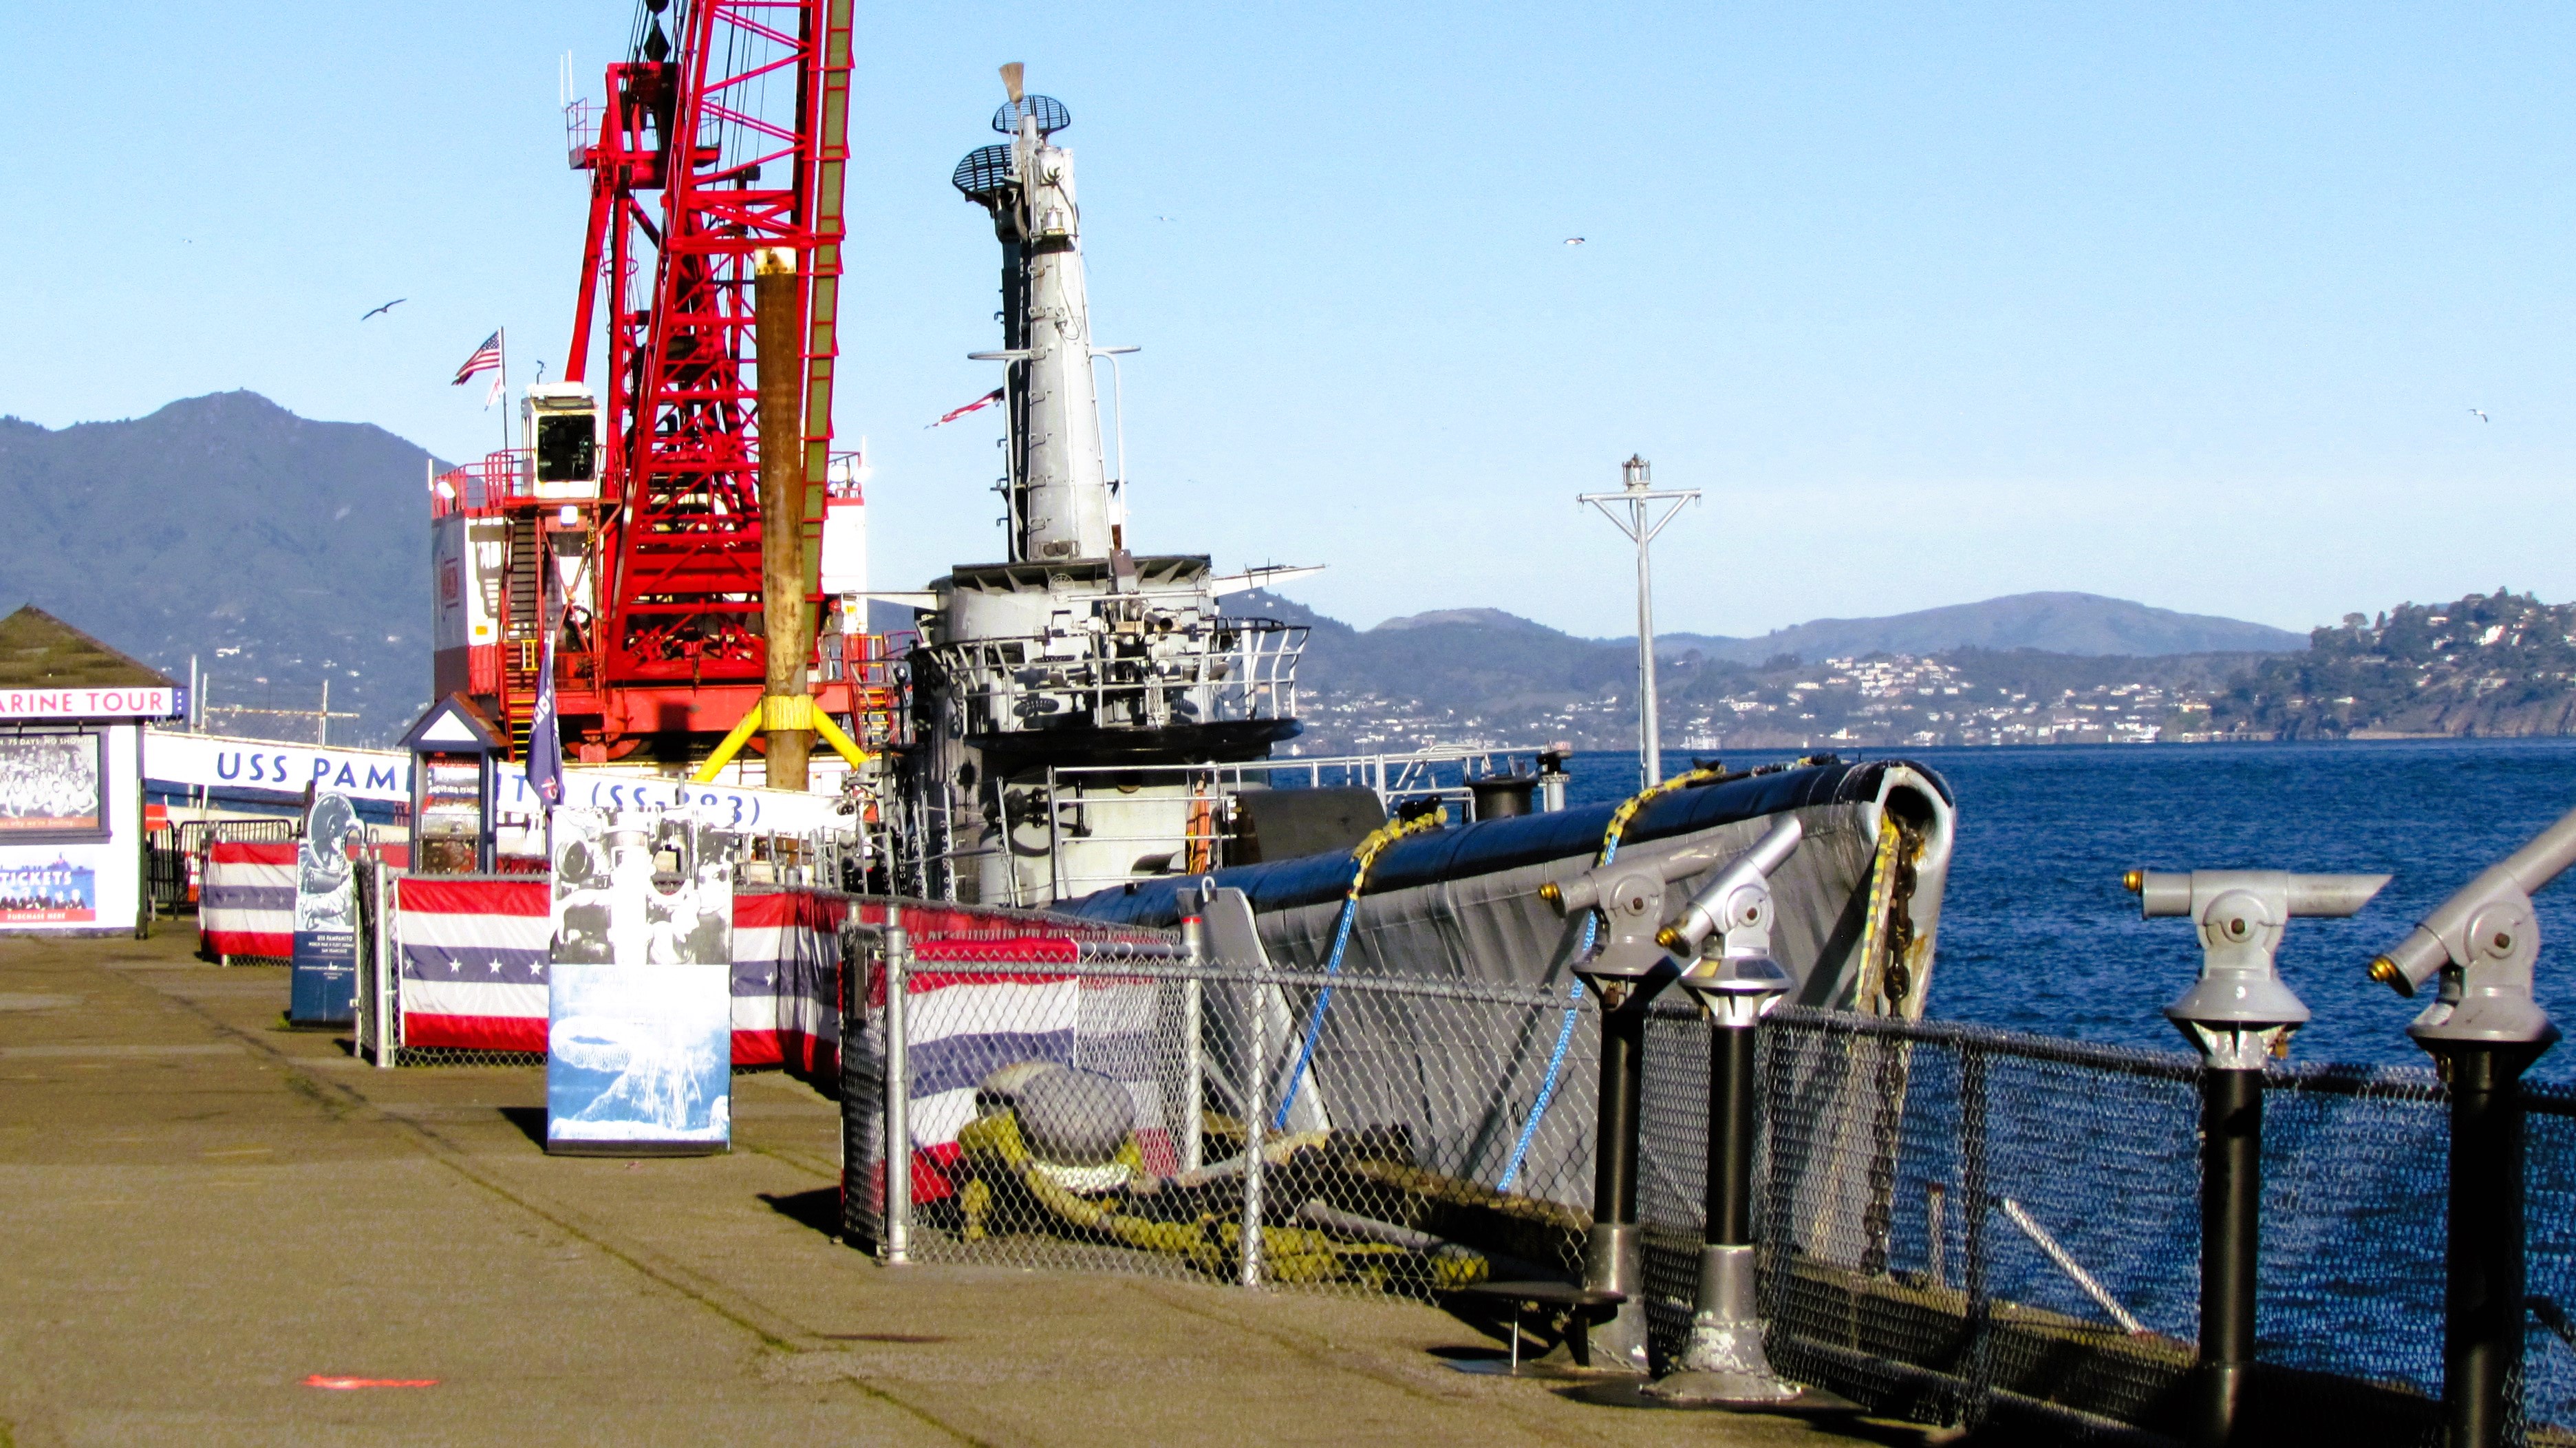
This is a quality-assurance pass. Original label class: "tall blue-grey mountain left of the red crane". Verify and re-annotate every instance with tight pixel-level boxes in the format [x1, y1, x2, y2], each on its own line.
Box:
[0, 392, 430, 742]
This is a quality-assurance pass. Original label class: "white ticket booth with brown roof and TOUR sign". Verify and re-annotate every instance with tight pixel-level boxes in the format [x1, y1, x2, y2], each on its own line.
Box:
[0, 606, 186, 935]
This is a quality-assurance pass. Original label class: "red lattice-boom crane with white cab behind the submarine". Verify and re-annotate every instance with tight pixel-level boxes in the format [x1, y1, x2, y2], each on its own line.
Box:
[433, 0, 886, 760]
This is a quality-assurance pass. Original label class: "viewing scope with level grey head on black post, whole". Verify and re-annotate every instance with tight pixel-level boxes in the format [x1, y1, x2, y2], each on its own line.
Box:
[2120, 871, 2388, 1448]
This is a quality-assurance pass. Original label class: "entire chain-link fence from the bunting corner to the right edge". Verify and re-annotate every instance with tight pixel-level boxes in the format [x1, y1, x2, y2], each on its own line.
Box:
[840, 930, 2576, 1443]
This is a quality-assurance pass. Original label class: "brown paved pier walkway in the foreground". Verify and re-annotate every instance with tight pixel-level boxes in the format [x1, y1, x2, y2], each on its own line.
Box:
[0, 925, 1922, 1448]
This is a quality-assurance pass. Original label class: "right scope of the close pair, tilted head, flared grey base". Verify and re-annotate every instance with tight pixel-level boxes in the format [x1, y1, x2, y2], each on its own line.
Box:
[1646, 822, 1813, 1409]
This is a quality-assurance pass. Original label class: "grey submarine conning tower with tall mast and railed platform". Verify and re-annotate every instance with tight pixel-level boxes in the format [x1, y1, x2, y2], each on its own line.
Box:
[907, 65, 1306, 904]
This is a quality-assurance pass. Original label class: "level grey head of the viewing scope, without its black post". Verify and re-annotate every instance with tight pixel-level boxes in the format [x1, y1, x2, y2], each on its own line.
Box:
[2123, 871, 2388, 1072]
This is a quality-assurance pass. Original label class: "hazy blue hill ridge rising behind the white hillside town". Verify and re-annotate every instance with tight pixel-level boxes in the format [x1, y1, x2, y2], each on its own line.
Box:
[1625, 593, 2308, 665]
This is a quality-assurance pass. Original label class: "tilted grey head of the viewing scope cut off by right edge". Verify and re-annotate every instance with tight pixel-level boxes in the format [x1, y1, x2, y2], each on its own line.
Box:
[2370, 811, 2576, 1043]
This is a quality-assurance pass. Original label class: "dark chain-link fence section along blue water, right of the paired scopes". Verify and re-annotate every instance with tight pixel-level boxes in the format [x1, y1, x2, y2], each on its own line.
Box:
[1741, 1010, 2576, 1445]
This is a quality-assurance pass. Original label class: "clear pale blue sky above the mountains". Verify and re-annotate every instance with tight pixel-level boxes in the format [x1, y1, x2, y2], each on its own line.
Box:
[0, 0, 2576, 634]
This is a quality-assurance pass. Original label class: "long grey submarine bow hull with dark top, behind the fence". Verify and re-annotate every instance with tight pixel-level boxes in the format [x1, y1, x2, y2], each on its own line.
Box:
[1059, 760, 1950, 1206]
